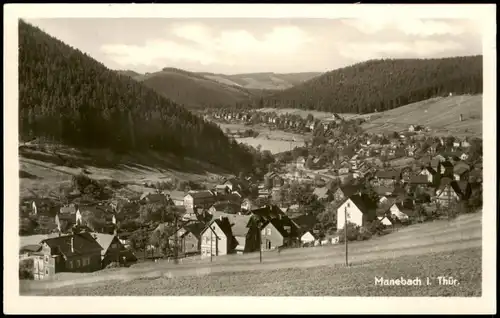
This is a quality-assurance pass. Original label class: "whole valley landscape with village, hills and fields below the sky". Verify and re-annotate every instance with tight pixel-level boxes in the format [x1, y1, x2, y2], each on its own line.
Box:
[14, 21, 484, 297]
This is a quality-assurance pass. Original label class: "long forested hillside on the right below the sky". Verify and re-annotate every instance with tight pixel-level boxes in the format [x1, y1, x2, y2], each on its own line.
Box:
[253, 56, 483, 114]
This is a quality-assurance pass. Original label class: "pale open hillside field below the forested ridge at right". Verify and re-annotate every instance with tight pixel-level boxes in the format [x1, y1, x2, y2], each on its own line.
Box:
[362, 95, 483, 136]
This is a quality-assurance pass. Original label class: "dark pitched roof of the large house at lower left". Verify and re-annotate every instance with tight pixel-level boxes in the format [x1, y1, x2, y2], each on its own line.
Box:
[41, 232, 102, 257]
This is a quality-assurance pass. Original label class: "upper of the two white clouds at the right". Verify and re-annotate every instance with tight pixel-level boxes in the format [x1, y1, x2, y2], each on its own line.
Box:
[343, 16, 465, 37]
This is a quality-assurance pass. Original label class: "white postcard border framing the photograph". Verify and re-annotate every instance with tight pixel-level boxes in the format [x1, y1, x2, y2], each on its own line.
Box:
[3, 4, 496, 314]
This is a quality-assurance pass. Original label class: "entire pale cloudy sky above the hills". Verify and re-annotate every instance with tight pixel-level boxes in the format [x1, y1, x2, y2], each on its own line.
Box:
[27, 16, 482, 74]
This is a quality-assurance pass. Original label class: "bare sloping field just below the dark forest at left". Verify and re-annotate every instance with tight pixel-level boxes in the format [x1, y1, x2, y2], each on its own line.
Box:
[19, 149, 230, 197]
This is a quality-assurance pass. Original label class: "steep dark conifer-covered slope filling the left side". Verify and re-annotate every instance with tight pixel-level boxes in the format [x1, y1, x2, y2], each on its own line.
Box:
[19, 21, 252, 170]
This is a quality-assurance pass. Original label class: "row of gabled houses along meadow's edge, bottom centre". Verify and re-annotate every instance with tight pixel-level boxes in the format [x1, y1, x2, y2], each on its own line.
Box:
[150, 205, 300, 257]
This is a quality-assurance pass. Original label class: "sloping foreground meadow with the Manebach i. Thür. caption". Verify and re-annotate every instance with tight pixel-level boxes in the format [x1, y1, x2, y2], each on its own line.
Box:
[20, 212, 482, 296]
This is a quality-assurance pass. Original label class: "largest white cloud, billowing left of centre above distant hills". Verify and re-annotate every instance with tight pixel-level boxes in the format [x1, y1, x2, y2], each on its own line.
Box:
[101, 23, 309, 66]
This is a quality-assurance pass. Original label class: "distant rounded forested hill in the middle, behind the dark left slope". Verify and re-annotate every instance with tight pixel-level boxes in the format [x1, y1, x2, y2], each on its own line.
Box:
[133, 68, 254, 108]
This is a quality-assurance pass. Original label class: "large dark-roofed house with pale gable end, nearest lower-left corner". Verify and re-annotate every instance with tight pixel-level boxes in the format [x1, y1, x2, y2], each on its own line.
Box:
[34, 232, 102, 279]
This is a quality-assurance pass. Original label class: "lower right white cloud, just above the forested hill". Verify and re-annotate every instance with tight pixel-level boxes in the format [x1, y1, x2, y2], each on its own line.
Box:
[337, 40, 464, 61]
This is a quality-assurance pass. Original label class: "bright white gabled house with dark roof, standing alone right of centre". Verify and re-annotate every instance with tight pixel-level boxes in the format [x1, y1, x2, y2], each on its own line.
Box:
[337, 195, 377, 230]
